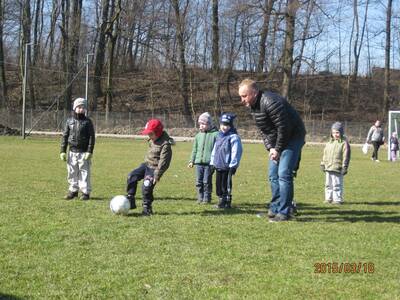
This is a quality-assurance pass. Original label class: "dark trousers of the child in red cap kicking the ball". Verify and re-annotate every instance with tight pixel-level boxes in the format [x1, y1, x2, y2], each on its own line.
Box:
[126, 163, 155, 205]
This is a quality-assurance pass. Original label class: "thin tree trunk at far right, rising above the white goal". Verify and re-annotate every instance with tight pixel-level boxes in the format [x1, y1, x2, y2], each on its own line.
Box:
[383, 0, 392, 117]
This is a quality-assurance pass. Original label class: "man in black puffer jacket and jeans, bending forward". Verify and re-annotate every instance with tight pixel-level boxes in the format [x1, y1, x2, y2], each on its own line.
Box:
[239, 79, 306, 222]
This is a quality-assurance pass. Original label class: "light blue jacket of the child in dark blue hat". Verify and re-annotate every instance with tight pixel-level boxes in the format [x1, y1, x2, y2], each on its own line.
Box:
[210, 128, 243, 170]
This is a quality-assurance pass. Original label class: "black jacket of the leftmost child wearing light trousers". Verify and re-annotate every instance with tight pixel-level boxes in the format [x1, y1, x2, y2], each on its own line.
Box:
[60, 114, 95, 153]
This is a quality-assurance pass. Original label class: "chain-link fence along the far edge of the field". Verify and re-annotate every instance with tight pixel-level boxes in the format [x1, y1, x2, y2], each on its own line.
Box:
[0, 109, 372, 143]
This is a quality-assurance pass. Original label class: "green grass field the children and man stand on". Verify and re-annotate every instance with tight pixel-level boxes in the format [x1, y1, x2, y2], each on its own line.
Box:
[0, 137, 400, 299]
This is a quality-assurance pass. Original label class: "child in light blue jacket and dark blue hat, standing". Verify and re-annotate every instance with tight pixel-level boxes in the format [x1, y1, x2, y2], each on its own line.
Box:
[210, 113, 243, 209]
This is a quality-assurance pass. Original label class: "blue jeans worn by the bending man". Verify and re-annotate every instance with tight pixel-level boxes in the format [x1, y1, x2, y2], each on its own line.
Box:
[269, 138, 304, 216]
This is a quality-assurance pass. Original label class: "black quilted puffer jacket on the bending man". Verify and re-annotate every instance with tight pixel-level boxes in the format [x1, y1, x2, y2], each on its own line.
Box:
[251, 91, 306, 152]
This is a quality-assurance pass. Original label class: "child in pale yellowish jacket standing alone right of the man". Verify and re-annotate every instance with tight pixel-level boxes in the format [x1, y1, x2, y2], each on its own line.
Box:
[321, 122, 350, 204]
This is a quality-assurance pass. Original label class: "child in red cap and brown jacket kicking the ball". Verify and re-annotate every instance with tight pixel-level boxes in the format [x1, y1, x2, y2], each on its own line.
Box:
[126, 119, 174, 216]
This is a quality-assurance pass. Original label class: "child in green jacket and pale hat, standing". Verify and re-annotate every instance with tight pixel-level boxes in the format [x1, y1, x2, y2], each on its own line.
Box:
[188, 112, 218, 204]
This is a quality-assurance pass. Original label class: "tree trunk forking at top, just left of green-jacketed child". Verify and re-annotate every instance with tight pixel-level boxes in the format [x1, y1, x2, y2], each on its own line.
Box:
[171, 0, 194, 127]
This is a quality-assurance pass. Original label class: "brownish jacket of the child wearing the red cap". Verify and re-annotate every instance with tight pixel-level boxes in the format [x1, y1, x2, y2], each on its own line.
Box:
[145, 131, 174, 180]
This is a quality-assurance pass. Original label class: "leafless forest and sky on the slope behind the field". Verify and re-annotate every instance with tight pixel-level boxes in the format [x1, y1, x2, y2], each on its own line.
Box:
[0, 0, 400, 123]
